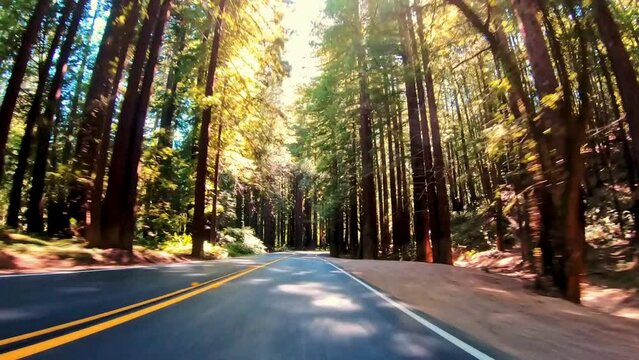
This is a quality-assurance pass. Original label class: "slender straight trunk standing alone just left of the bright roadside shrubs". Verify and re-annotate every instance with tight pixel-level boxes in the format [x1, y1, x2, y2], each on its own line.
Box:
[191, 0, 226, 257]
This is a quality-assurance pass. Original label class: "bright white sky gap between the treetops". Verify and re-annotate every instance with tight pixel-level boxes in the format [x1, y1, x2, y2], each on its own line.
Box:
[282, 0, 324, 106]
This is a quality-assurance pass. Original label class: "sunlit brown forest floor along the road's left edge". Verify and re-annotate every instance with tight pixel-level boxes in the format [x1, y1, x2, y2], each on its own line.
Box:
[0, 231, 191, 274]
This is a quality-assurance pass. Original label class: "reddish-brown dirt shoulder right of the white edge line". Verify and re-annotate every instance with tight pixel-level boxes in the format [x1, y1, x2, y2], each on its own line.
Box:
[330, 258, 639, 359]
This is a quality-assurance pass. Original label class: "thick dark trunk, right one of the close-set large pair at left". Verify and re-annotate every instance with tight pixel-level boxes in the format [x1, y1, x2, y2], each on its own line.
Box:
[99, 0, 172, 251]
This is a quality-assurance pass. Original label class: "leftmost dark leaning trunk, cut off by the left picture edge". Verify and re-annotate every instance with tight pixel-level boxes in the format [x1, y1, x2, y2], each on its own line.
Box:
[0, 0, 51, 181]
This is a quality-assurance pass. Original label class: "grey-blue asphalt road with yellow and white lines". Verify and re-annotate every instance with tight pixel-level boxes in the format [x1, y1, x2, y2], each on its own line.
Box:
[0, 253, 497, 360]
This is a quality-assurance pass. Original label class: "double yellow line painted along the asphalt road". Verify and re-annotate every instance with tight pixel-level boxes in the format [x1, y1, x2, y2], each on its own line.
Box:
[0, 256, 290, 360]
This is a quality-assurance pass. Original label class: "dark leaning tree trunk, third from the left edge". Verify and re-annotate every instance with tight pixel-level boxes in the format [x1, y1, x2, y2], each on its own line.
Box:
[27, 0, 88, 232]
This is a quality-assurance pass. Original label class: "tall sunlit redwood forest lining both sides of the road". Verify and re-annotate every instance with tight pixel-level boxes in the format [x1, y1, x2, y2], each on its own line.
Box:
[0, 0, 639, 303]
